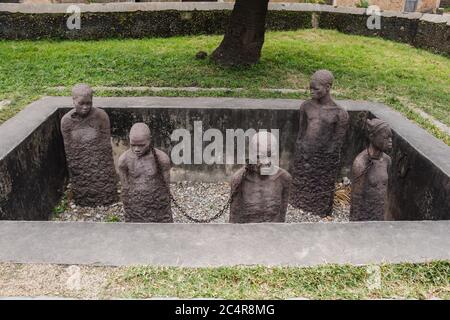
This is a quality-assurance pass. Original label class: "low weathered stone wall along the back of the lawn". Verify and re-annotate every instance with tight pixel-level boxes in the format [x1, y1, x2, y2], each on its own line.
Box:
[0, 2, 450, 55]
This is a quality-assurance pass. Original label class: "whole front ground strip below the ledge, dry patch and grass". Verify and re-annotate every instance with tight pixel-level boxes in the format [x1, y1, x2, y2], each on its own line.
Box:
[0, 261, 450, 299]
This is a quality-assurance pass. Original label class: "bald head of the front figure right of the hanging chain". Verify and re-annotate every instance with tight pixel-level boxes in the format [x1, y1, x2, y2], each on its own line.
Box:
[250, 131, 279, 175]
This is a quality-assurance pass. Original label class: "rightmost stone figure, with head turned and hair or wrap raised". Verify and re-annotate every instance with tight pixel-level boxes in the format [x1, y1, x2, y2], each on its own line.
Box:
[350, 119, 392, 221]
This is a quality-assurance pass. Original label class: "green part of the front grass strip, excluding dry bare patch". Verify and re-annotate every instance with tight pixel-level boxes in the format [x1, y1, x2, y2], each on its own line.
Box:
[109, 261, 450, 299]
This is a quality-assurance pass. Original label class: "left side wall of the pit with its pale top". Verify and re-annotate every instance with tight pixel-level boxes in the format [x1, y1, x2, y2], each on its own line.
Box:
[0, 103, 67, 220]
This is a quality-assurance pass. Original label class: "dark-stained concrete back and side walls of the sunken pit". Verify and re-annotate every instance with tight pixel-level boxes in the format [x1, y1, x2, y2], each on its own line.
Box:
[0, 97, 450, 220]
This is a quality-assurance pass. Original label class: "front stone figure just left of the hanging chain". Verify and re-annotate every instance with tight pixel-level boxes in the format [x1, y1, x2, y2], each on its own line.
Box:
[119, 123, 173, 222]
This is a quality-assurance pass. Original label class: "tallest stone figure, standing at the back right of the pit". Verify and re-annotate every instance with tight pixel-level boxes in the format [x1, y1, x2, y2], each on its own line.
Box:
[290, 70, 349, 216]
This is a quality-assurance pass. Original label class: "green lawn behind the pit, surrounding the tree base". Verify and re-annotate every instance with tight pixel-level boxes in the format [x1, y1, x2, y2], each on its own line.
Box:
[0, 30, 450, 145]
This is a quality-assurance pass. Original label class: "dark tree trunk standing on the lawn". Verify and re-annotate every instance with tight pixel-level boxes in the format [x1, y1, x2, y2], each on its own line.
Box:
[212, 0, 269, 66]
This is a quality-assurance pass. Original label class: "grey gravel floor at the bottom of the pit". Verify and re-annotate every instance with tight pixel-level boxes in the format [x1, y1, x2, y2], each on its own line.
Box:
[53, 181, 350, 223]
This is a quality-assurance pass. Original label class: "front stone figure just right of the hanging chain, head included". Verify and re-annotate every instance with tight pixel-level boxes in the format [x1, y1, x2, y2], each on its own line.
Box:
[230, 132, 292, 223]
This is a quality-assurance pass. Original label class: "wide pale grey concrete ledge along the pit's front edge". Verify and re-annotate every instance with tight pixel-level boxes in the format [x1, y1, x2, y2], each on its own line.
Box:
[0, 221, 450, 267]
